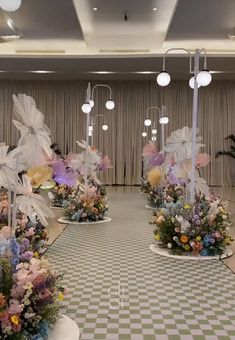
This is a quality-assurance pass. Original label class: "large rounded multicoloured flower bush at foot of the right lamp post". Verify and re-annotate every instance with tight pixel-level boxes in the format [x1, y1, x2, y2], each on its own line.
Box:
[151, 195, 232, 256]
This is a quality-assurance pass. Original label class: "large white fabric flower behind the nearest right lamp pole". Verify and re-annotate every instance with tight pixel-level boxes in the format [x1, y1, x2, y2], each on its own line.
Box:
[164, 126, 204, 162]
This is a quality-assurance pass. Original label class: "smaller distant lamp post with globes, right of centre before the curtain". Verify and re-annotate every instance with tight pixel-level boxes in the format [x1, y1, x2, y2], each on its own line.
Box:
[142, 105, 169, 149]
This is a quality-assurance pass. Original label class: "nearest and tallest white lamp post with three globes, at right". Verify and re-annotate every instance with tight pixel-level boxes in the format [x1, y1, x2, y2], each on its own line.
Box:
[157, 48, 212, 203]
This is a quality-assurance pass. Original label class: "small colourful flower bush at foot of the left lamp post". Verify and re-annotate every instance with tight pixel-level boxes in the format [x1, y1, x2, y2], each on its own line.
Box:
[64, 185, 108, 222]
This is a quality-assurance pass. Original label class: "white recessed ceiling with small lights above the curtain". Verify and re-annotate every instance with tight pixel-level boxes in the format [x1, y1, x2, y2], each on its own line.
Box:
[0, 0, 235, 79]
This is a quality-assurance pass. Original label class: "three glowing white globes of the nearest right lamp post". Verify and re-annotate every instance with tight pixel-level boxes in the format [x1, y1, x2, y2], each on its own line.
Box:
[157, 70, 212, 89]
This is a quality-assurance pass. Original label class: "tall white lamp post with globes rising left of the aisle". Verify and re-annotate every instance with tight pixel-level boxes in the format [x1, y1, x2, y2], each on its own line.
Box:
[82, 83, 115, 193]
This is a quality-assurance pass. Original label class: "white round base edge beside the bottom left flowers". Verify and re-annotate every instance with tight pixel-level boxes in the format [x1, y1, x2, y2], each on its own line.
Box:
[48, 315, 80, 340]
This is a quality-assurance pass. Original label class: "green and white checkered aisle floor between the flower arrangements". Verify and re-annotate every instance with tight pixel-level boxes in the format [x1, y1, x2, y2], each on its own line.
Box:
[47, 192, 235, 340]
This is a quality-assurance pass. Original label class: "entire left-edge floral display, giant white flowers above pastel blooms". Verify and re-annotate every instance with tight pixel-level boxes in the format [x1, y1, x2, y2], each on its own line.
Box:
[0, 94, 64, 340]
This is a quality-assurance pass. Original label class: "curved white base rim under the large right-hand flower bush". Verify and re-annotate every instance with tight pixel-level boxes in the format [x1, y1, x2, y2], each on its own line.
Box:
[149, 243, 233, 261]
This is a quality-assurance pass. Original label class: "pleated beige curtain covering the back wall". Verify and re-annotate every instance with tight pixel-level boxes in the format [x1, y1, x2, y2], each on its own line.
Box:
[0, 80, 235, 186]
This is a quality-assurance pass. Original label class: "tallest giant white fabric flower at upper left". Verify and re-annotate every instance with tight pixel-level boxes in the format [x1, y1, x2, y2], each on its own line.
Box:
[13, 94, 52, 166]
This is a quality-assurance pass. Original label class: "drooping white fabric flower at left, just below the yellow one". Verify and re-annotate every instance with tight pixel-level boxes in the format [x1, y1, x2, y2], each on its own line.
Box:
[16, 175, 54, 225]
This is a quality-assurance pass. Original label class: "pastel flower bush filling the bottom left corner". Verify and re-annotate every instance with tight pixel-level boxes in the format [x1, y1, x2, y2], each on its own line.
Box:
[0, 232, 65, 340]
